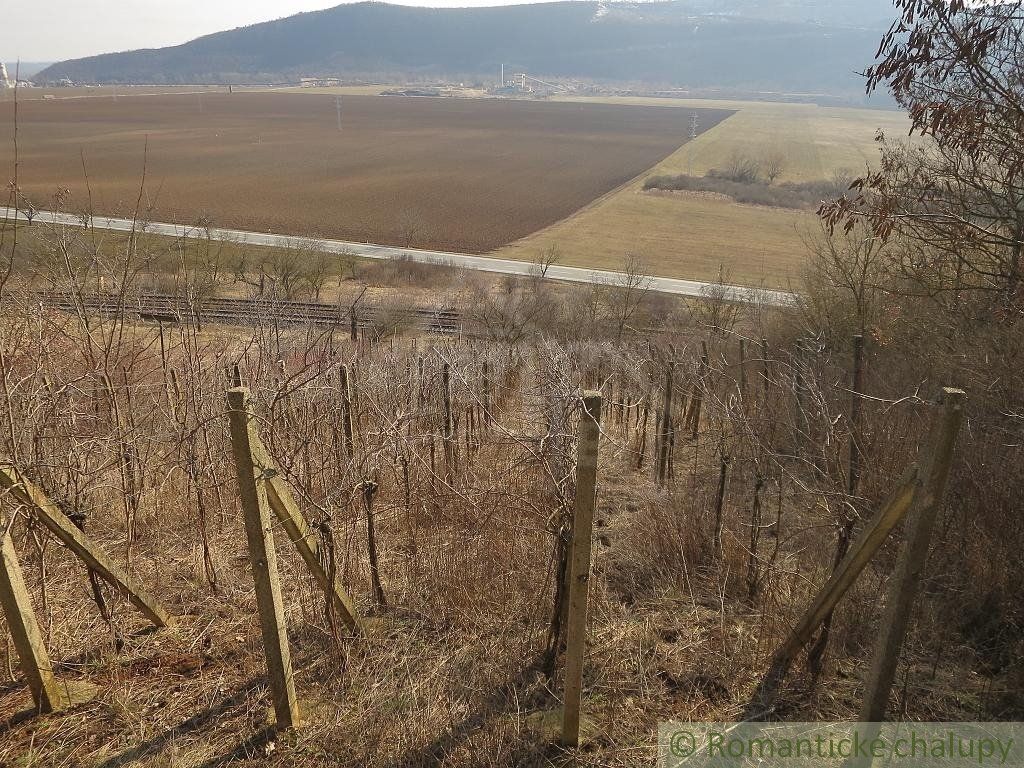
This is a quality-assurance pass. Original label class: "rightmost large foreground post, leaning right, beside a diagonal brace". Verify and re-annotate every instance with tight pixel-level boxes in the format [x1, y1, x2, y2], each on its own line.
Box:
[860, 388, 967, 723]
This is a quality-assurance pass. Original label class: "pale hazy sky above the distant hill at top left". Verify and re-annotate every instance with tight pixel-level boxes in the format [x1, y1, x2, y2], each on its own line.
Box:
[9, 0, 544, 61]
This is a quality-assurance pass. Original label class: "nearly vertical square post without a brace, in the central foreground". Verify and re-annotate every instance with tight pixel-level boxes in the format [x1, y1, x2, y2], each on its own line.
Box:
[561, 392, 601, 748]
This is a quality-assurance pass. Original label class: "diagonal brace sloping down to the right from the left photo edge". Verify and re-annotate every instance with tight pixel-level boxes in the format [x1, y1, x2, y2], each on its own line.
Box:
[0, 459, 171, 627]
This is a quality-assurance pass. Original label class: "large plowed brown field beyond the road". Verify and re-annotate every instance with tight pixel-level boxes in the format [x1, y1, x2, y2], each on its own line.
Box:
[0, 93, 731, 253]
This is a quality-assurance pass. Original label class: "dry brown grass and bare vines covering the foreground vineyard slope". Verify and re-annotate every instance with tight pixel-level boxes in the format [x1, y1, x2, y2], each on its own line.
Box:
[0, 100, 1024, 768]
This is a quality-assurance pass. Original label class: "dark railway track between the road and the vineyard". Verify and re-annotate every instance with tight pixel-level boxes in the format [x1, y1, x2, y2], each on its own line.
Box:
[36, 291, 462, 335]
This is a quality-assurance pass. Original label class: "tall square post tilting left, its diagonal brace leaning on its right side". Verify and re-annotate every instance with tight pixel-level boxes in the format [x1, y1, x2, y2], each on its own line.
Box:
[227, 387, 299, 728]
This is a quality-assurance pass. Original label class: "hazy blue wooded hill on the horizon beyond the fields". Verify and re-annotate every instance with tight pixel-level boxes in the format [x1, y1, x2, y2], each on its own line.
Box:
[36, 0, 892, 93]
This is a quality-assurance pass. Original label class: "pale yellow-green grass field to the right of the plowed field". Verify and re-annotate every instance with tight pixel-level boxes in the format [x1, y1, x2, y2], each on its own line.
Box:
[495, 98, 907, 288]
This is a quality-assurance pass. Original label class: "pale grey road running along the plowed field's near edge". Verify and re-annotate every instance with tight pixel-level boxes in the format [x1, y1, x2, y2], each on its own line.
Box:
[0, 206, 796, 306]
